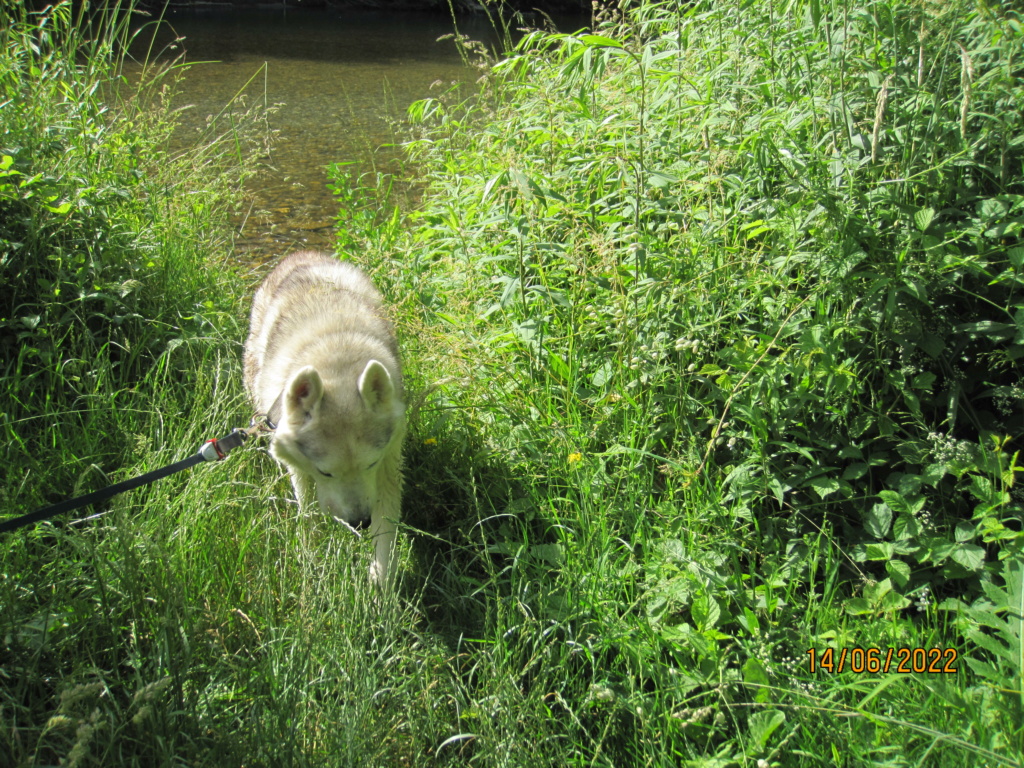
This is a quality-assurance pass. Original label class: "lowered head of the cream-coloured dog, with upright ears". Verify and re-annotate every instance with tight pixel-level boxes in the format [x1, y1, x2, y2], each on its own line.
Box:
[271, 359, 403, 527]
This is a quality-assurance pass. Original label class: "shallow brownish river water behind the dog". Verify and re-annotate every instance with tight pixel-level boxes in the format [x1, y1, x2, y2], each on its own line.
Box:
[142, 6, 509, 261]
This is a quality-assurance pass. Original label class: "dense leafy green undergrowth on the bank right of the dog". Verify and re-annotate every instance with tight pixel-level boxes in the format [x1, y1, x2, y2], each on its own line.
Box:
[375, 1, 1024, 765]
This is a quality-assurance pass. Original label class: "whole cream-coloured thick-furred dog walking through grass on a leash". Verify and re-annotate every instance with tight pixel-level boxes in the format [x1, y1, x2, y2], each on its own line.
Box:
[245, 251, 406, 583]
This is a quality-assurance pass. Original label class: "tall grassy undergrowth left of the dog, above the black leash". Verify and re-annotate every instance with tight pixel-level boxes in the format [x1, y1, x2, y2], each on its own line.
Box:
[0, 3, 268, 506]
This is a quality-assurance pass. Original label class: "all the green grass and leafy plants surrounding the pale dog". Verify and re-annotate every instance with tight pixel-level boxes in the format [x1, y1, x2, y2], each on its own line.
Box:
[0, 0, 1024, 768]
